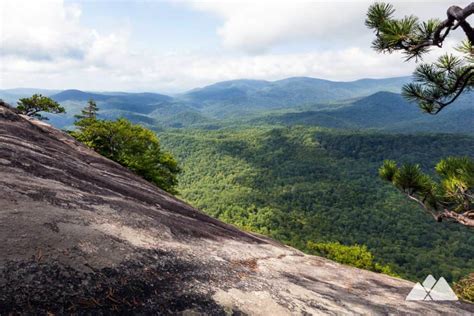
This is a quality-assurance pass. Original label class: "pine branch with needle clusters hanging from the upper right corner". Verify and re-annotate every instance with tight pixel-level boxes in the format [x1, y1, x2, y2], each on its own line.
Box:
[365, 3, 474, 114]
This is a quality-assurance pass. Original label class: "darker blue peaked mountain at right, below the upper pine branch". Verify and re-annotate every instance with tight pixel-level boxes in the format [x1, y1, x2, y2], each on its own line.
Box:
[258, 92, 474, 134]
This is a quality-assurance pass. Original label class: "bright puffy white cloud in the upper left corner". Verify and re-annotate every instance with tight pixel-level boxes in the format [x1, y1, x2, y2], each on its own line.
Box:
[0, 0, 127, 65]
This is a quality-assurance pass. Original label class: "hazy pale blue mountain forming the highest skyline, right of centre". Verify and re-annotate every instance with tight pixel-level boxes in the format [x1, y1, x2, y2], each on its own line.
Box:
[180, 77, 410, 117]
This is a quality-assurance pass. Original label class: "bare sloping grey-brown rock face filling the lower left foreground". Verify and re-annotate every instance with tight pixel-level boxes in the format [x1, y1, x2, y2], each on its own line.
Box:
[0, 105, 474, 315]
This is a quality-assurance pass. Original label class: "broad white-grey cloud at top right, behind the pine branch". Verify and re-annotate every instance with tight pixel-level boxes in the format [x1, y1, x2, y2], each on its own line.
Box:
[188, 0, 470, 53]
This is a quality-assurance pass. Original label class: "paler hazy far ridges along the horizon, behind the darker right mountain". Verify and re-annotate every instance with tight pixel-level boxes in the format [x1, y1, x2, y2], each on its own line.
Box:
[0, 77, 408, 126]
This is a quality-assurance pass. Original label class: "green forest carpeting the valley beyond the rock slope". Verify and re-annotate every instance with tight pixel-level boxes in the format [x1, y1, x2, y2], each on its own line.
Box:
[159, 126, 474, 281]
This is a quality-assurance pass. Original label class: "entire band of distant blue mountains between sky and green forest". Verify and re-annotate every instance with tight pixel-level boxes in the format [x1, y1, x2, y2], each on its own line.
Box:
[0, 77, 474, 134]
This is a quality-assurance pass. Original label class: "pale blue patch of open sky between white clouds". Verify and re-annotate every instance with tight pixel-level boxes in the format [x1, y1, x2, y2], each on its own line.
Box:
[74, 1, 221, 51]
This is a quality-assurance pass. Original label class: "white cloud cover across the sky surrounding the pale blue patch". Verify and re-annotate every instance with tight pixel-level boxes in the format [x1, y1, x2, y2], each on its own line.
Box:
[0, 0, 470, 92]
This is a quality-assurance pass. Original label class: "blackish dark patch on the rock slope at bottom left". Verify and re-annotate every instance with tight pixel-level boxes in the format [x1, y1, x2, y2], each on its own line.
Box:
[0, 250, 238, 315]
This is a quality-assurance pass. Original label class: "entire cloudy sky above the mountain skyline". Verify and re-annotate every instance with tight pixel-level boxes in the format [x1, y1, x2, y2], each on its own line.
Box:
[0, 0, 470, 93]
